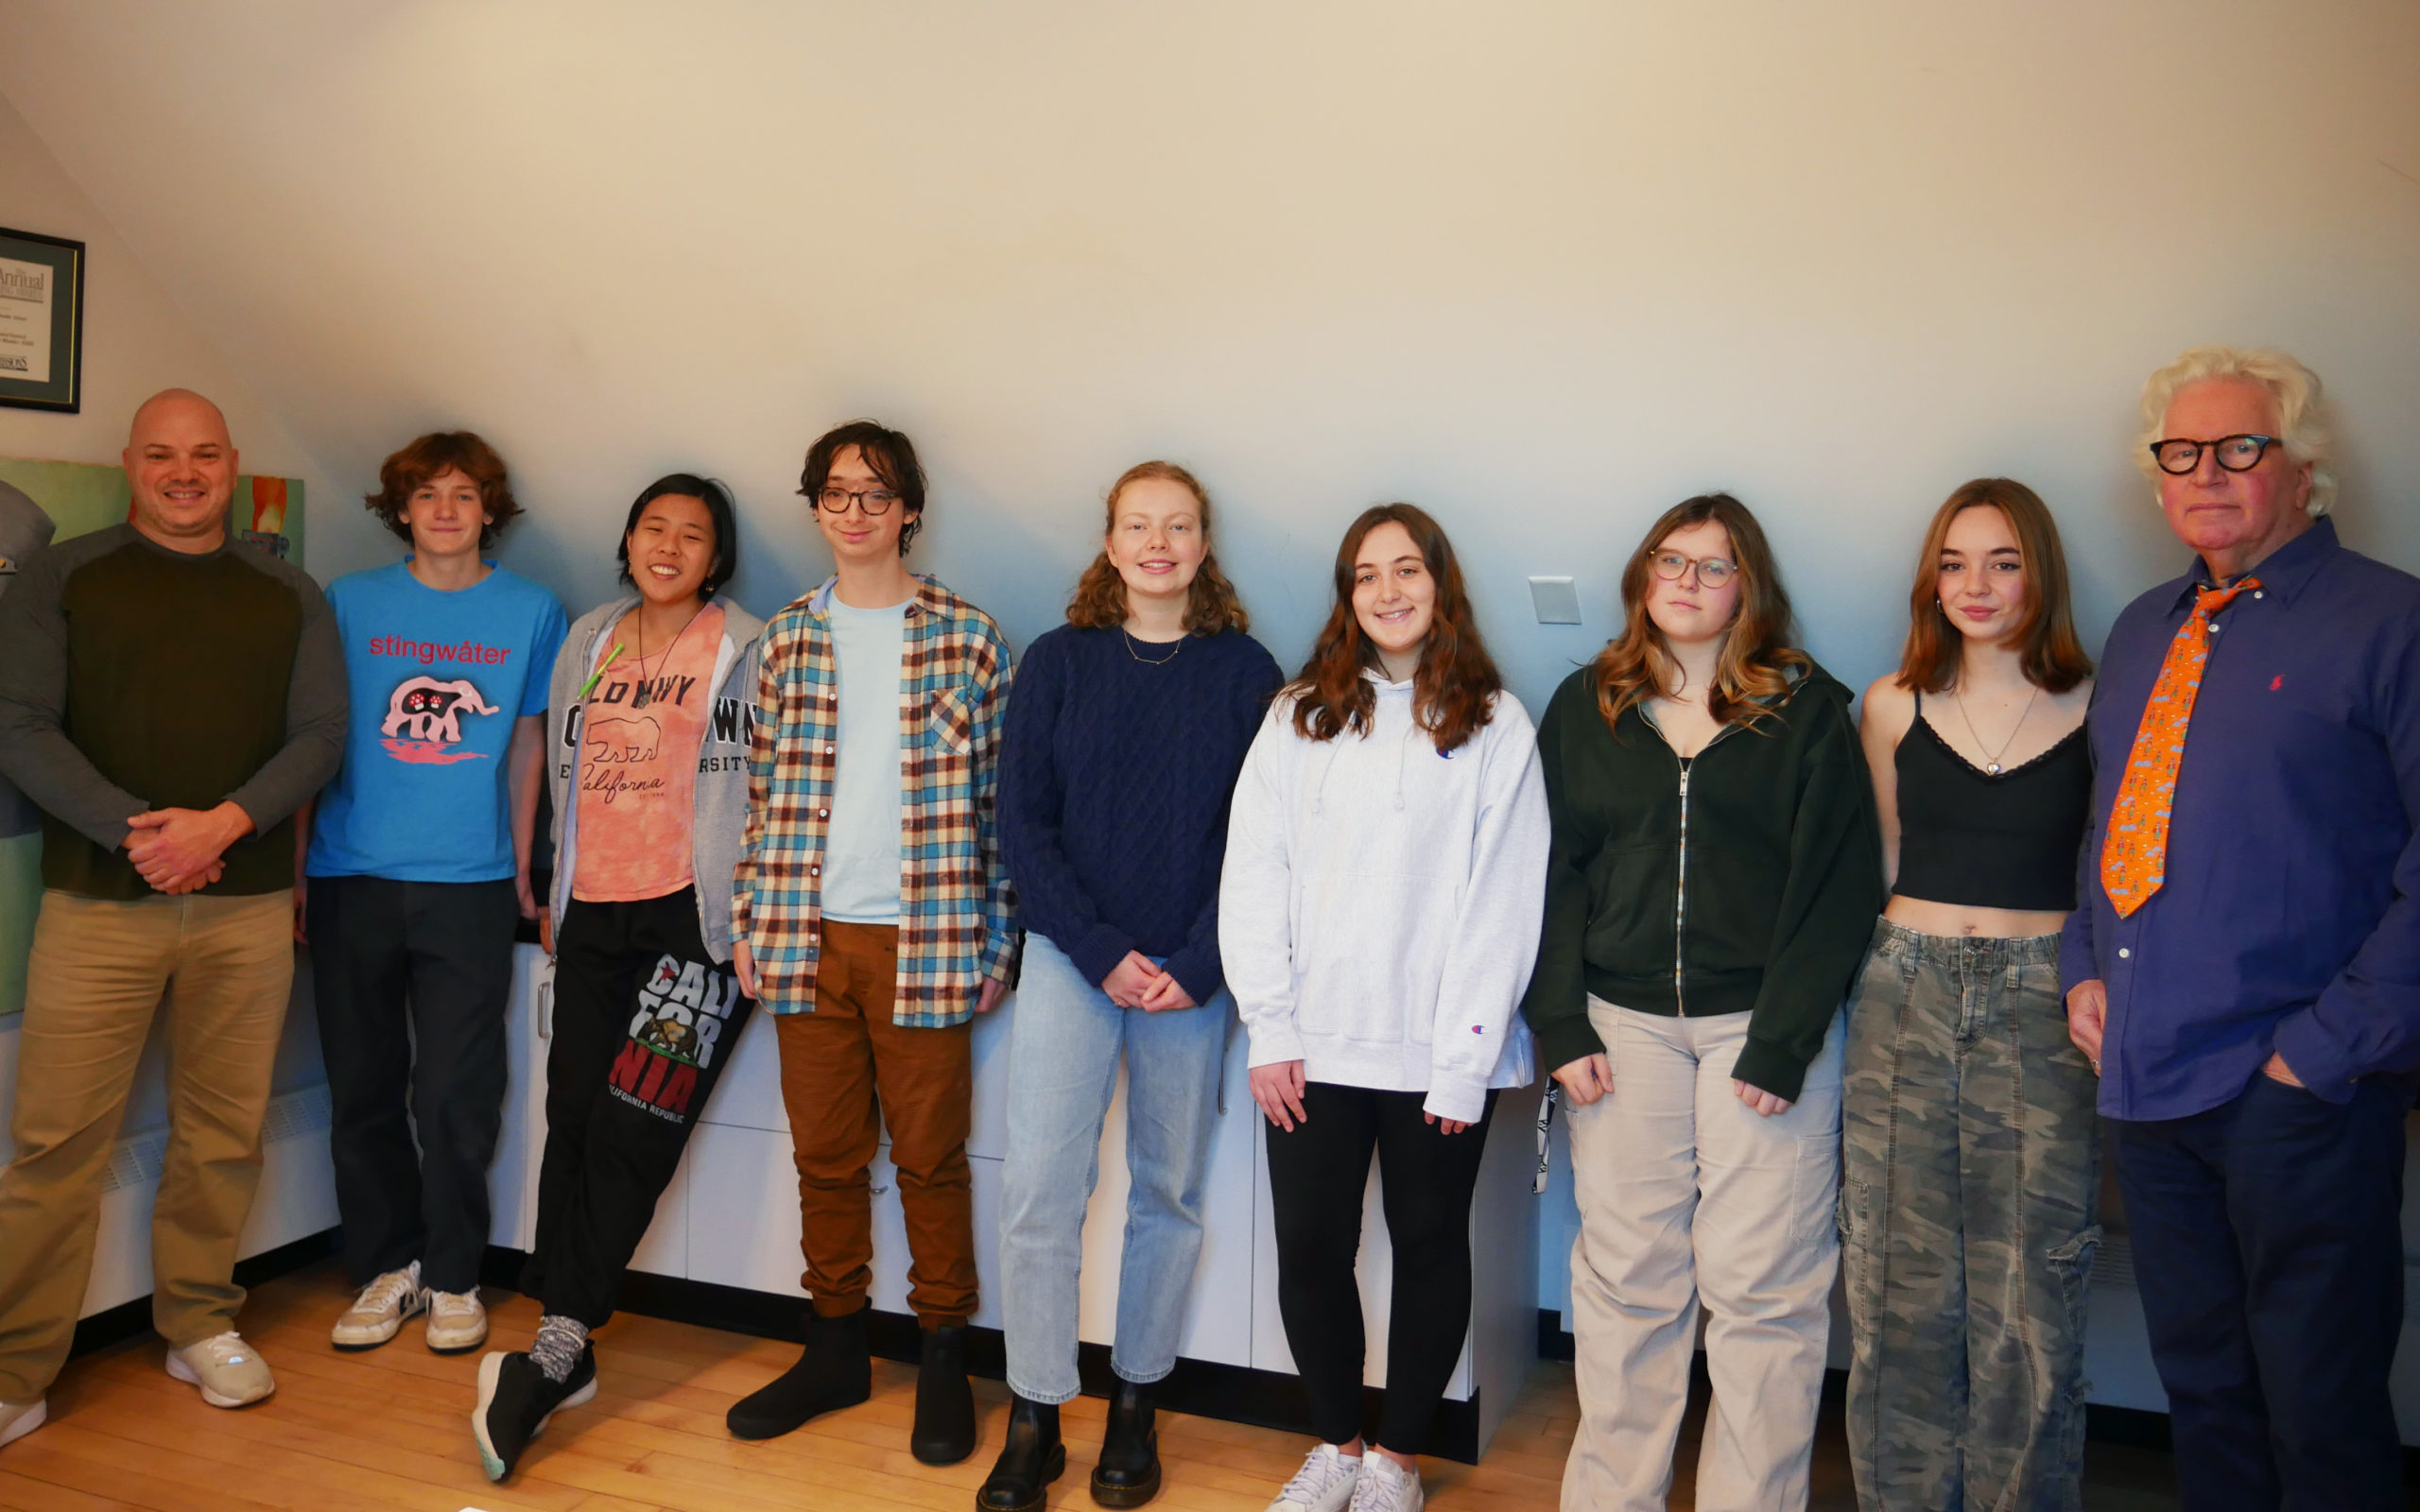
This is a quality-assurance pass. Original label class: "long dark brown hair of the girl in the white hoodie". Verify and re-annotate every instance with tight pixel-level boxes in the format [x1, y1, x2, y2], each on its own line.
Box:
[1285, 503, 1505, 752]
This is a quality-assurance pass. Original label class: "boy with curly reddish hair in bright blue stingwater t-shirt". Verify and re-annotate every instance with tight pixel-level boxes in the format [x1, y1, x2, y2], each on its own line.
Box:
[295, 431, 563, 1355]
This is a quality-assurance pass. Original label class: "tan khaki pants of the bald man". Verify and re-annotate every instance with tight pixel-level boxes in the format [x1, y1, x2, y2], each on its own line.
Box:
[0, 890, 295, 1403]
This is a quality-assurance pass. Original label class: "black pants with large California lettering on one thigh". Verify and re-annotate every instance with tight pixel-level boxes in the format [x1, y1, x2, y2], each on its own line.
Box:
[520, 888, 755, 1328]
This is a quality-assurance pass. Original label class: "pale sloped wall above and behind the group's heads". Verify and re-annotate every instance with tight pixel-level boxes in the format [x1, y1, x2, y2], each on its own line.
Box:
[0, 0, 2420, 704]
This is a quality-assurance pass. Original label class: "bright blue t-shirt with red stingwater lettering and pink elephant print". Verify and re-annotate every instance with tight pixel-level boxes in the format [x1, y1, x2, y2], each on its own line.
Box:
[302, 561, 566, 883]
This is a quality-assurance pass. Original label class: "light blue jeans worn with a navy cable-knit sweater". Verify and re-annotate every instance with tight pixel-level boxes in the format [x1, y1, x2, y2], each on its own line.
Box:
[999, 934, 1235, 1403]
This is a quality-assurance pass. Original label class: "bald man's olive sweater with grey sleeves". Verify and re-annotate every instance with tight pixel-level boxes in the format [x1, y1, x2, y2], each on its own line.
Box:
[0, 525, 346, 900]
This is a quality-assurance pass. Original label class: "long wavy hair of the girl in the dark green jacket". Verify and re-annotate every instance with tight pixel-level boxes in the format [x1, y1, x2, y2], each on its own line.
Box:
[1590, 493, 1815, 726]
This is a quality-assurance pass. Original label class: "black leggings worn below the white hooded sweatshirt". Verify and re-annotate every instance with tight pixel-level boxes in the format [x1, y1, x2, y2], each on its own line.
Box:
[1268, 1081, 1495, 1454]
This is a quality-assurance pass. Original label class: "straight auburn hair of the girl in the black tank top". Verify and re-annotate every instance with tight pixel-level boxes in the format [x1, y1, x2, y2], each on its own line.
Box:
[1897, 476, 2093, 692]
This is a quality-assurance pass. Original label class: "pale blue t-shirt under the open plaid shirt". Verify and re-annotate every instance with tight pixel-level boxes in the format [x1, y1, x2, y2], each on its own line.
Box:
[822, 595, 910, 924]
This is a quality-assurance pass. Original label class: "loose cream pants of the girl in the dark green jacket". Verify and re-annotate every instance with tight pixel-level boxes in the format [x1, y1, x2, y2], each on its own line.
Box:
[1564, 997, 1841, 1512]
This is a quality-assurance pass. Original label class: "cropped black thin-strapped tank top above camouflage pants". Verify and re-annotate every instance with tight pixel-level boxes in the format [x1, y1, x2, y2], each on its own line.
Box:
[1893, 692, 2093, 912]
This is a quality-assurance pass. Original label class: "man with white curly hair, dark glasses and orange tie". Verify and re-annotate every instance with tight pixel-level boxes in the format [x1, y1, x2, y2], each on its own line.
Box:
[2060, 346, 2420, 1512]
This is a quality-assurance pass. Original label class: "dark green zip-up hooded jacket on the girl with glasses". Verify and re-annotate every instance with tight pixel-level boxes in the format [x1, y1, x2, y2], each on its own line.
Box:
[1522, 668, 1883, 1101]
